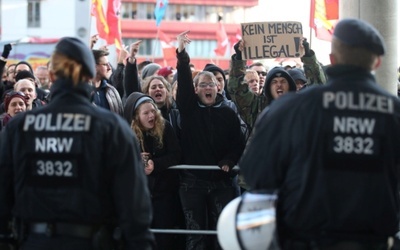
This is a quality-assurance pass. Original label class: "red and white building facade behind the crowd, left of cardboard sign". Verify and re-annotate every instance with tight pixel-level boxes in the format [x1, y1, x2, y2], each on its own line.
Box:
[121, 0, 258, 69]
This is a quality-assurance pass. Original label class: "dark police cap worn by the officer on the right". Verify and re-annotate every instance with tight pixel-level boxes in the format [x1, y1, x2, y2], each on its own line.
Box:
[333, 18, 385, 55]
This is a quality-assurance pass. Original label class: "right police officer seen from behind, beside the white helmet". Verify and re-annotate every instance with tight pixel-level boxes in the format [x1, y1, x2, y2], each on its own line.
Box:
[239, 19, 400, 250]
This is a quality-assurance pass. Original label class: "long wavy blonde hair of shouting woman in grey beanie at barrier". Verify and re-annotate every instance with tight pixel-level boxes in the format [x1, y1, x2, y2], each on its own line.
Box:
[131, 101, 165, 152]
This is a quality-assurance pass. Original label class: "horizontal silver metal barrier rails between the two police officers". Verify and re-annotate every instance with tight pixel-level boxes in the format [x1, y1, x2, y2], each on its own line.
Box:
[150, 164, 239, 235]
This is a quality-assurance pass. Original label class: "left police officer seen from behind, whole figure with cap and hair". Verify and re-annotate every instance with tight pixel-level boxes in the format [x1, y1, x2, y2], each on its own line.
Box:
[0, 38, 154, 249]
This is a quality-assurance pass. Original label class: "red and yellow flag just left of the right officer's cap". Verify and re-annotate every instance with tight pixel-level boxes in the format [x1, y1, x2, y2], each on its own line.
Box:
[310, 0, 339, 41]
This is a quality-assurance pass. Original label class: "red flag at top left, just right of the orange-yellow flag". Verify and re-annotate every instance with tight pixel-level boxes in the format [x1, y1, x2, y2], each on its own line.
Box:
[107, 0, 122, 51]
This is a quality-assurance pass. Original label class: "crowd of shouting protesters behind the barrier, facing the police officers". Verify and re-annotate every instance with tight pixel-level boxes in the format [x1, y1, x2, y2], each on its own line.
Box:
[0, 20, 400, 250]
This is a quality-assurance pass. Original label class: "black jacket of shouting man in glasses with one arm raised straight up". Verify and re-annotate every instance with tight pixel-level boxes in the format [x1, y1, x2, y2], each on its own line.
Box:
[176, 50, 244, 181]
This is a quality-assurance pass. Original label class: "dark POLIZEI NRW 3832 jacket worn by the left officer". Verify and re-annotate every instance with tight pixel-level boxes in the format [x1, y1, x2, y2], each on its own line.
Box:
[0, 77, 153, 249]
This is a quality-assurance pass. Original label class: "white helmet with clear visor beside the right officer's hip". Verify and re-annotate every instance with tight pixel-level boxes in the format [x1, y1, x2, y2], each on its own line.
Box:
[217, 193, 276, 250]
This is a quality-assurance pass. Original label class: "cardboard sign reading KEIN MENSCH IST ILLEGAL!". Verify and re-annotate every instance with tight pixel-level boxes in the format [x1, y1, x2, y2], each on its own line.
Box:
[241, 22, 303, 60]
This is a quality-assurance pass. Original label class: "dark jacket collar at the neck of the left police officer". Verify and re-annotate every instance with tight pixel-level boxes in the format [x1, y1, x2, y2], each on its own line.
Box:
[50, 78, 93, 100]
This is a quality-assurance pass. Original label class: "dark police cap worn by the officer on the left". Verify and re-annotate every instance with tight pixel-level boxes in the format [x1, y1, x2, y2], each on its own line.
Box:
[55, 37, 96, 77]
